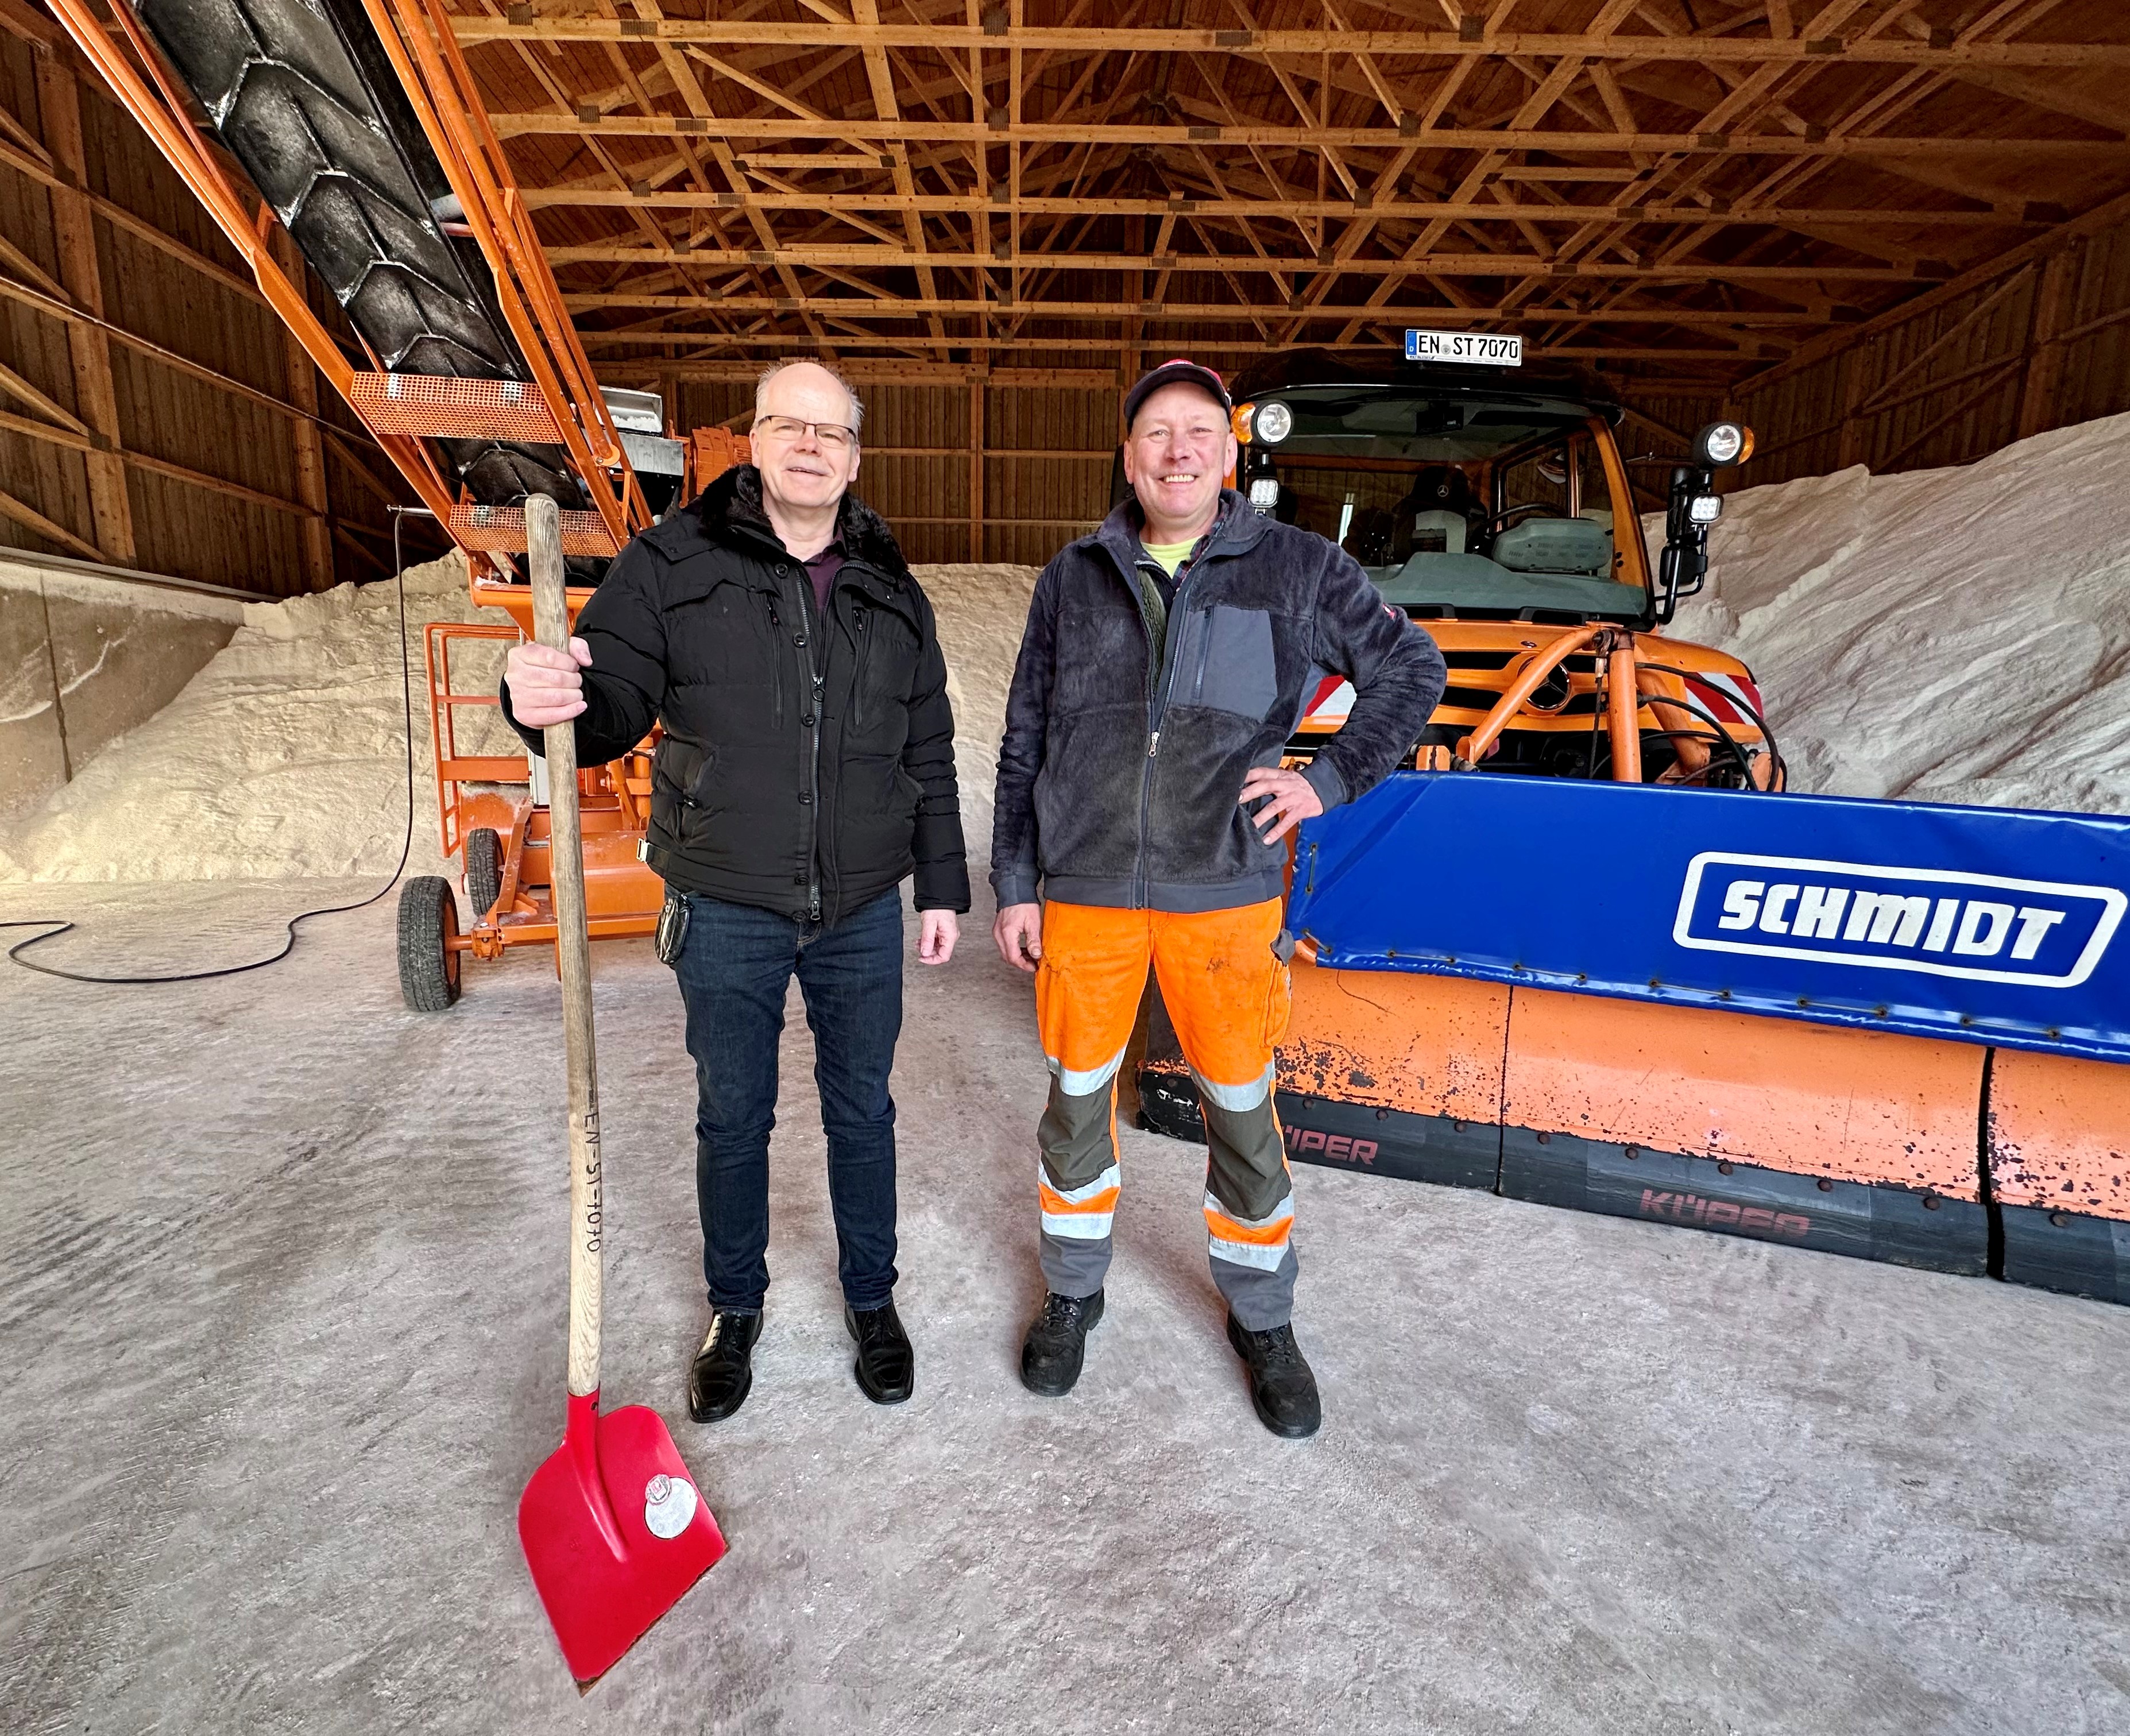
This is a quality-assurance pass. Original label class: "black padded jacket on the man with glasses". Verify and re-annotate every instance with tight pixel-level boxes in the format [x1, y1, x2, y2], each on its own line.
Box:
[502, 465, 969, 922]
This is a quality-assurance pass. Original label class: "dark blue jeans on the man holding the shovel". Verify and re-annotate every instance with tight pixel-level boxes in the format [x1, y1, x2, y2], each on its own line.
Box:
[673, 888, 903, 1312]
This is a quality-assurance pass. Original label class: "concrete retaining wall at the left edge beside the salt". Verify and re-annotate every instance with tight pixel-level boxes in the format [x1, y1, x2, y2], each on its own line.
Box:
[0, 552, 245, 814]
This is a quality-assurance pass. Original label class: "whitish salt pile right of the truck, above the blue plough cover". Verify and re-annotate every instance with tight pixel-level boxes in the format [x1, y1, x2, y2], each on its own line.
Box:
[1644, 415, 2130, 814]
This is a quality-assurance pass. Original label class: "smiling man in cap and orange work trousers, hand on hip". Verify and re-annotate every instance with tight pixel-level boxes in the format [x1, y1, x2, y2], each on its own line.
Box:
[991, 362, 1444, 1436]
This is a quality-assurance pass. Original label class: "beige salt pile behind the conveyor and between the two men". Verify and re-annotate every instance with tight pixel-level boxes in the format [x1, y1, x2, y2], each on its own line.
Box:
[0, 556, 1035, 882]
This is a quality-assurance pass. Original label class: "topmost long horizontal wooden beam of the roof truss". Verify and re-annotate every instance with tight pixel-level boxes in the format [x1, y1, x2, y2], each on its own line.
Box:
[451, 15, 2130, 70]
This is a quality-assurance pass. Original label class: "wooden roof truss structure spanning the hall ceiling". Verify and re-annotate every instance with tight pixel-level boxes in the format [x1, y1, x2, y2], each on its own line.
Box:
[447, 0, 2130, 385]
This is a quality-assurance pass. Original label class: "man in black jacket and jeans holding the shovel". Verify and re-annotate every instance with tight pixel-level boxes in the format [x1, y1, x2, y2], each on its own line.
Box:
[502, 362, 969, 1423]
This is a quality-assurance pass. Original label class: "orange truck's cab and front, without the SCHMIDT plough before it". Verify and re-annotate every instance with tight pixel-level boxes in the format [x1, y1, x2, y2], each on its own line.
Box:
[1235, 345, 1783, 788]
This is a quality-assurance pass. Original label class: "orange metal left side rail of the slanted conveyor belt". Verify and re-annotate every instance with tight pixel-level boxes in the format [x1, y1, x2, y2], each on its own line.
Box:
[51, 0, 451, 524]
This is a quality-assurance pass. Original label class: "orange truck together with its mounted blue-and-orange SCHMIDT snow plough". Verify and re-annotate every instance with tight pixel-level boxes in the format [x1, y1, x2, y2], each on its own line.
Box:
[1135, 343, 2130, 1301]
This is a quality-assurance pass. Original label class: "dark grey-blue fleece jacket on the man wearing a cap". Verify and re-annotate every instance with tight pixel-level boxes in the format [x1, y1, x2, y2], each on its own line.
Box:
[991, 490, 1444, 912]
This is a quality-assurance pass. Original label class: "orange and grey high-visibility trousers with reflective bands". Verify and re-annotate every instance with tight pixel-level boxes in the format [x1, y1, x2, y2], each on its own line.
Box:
[1035, 899, 1295, 1331]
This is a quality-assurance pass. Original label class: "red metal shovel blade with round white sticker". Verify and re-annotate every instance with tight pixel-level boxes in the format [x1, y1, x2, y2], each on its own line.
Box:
[517, 1393, 724, 1687]
